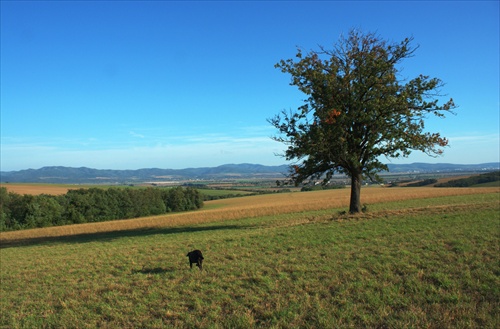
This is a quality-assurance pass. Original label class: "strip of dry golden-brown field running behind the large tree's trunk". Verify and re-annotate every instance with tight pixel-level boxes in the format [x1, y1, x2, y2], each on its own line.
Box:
[0, 187, 500, 243]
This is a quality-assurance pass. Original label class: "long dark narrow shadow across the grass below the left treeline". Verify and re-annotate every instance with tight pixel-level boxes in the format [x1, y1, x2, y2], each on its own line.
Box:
[0, 225, 248, 249]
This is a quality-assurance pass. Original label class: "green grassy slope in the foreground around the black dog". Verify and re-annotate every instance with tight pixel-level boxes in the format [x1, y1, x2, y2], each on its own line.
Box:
[0, 193, 500, 328]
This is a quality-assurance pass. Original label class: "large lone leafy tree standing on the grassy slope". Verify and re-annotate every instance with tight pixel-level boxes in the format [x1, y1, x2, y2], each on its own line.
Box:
[268, 30, 455, 213]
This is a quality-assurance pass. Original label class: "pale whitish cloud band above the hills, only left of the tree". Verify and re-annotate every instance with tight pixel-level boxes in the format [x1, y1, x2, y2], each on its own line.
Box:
[1, 134, 284, 171]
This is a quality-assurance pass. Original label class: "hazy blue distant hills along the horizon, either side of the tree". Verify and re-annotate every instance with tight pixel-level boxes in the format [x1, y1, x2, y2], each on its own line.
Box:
[0, 162, 500, 184]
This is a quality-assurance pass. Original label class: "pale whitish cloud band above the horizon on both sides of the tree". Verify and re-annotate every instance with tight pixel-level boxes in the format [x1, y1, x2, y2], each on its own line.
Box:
[0, 127, 500, 171]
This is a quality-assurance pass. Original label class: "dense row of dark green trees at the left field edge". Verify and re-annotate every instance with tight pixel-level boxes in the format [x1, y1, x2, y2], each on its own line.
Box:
[0, 187, 203, 231]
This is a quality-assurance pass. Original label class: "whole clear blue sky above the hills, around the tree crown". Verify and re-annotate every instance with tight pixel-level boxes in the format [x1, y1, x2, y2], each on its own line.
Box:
[0, 1, 500, 171]
